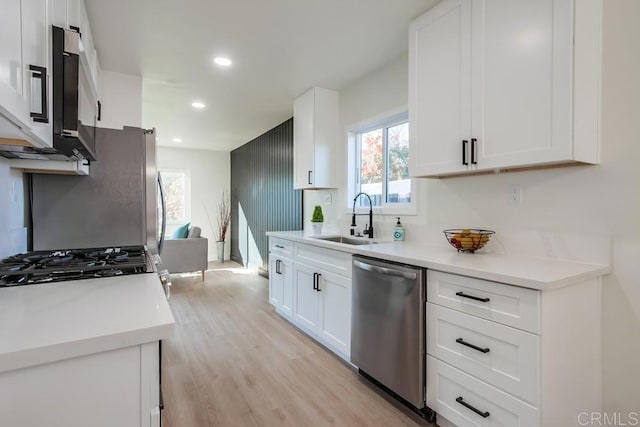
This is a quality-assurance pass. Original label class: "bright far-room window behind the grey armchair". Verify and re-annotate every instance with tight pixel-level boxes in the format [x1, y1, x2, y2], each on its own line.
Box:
[160, 169, 191, 224]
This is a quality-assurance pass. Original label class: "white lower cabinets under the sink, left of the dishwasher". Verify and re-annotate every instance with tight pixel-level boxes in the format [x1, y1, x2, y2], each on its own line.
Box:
[269, 238, 351, 361]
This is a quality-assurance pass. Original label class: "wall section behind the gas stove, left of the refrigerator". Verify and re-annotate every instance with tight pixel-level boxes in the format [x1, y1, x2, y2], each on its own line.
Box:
[0, 157, 27, 259]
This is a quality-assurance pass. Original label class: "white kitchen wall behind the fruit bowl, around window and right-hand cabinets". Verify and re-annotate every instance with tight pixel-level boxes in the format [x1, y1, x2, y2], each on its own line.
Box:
[322, 0, 640, 414]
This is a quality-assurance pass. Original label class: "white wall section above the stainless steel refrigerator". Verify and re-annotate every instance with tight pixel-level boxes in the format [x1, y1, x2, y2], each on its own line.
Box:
[99, 70, 142, 129]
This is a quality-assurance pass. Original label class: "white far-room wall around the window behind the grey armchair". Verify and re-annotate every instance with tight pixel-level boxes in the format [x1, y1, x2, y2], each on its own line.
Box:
[158, 147, 231, 261]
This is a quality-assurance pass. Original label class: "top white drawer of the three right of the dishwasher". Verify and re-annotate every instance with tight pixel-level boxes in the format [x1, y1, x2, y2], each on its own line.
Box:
[427, 270, 540, 333]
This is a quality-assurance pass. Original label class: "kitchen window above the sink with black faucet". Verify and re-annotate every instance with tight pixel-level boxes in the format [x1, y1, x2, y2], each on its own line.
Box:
[352, 112, 412, 208]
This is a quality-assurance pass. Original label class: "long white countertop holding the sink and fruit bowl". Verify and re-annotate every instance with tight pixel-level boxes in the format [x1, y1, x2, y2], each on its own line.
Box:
[267, 231, 610, 291]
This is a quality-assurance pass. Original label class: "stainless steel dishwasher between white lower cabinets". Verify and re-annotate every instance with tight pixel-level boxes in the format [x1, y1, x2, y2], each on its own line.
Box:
[351, 256, 434, 418]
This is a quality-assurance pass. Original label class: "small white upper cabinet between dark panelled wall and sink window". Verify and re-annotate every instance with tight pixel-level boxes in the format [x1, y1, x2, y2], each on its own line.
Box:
[293, 87, 338, 189]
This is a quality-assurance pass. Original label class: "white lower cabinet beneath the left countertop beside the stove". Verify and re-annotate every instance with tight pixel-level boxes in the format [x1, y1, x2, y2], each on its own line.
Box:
[0, 341, 160, 427]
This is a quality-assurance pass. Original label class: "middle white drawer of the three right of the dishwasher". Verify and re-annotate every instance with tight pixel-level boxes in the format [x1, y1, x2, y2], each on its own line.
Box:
[427, 303, 539, 406]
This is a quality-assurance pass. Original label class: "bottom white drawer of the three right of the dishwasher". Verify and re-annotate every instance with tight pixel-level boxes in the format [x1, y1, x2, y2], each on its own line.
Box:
[427, 356, 540, 427]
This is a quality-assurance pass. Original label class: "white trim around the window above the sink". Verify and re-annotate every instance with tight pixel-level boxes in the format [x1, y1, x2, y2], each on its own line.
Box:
[345, 105, 418, 216]
